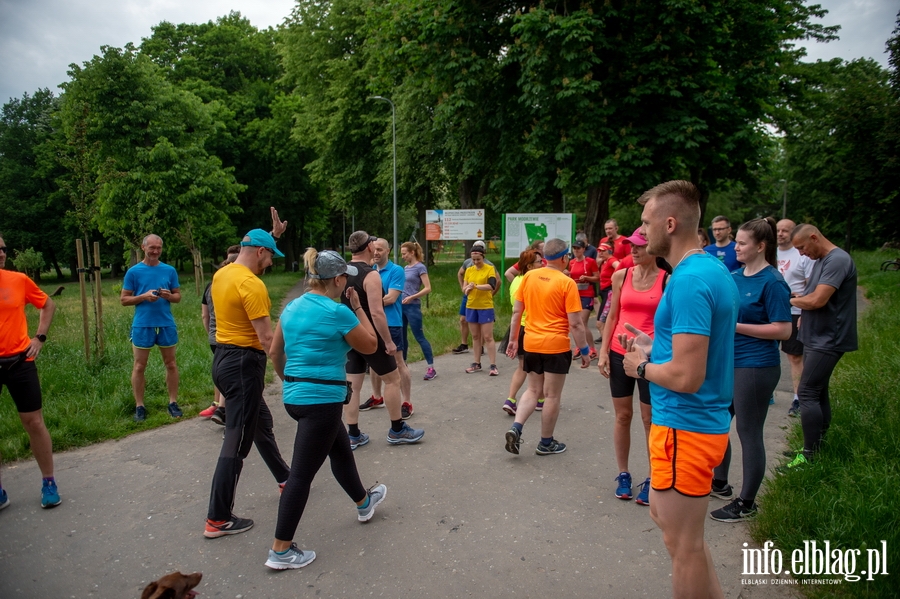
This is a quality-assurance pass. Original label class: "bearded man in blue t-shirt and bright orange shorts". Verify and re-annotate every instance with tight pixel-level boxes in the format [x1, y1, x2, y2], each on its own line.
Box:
[620, 181, 739, 598]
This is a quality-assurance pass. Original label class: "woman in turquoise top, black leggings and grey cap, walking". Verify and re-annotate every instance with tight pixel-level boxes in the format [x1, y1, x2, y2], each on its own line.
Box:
[266, 248, 387, 570]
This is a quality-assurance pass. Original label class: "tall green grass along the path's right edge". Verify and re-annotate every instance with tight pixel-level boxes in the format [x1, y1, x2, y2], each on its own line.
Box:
[751, 252, 900, 598]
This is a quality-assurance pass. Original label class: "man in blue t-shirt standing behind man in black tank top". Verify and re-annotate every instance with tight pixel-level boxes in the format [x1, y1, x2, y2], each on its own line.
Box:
[369, 238, 413, 420]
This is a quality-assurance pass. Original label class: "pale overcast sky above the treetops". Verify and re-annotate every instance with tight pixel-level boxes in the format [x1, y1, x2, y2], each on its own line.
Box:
[0, 0, 900, 103]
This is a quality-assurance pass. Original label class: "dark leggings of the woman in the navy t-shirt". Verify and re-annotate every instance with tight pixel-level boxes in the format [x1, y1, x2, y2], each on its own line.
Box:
[713, 366, 781, 502]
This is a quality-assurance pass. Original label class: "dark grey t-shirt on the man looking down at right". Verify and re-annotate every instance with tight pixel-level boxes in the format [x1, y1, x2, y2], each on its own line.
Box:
[797, 248, 859, 353]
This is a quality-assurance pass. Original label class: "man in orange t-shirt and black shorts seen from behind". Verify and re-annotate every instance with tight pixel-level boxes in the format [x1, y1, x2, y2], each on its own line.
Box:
[506, 239, 591, 455]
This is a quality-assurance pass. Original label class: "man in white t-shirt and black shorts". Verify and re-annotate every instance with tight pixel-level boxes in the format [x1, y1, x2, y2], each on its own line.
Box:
[776, 218, 814, 416]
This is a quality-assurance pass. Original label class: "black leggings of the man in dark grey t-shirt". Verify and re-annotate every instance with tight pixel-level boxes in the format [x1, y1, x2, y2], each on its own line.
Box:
[797, 347, 844, 453]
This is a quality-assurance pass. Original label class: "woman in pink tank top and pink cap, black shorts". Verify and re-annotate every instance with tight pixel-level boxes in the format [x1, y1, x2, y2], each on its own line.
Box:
[598, 230, 667, 505]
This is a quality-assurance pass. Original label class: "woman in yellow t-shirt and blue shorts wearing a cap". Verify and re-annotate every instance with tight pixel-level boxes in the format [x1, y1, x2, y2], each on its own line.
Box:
[463, 246, 500, 376]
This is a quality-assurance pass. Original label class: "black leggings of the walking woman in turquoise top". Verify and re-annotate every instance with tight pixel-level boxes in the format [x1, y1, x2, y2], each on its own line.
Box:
[275, 402, 366, 541]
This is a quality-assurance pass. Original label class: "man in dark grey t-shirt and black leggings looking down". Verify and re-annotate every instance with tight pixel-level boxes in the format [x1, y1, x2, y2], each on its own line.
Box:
[787, 224, 858, 468]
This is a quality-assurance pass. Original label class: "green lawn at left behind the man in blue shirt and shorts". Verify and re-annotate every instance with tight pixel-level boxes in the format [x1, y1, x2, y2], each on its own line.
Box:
[0, 273, 299, 460]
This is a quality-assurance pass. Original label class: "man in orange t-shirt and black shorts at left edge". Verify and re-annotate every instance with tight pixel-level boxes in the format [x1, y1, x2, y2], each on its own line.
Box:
[0, 237, 62, 510]
